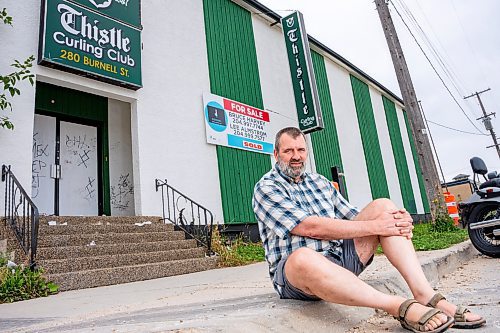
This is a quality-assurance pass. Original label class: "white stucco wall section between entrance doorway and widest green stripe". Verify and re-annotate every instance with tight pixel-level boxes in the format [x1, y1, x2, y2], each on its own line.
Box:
[134, 0, 223, 221]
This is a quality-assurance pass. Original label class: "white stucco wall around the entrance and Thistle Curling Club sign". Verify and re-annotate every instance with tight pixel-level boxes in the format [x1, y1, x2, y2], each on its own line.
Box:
[0, 0, 222, 220]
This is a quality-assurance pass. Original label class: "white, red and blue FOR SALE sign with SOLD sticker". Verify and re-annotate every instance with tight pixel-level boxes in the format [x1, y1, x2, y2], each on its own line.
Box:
[203, 93, 274, 154]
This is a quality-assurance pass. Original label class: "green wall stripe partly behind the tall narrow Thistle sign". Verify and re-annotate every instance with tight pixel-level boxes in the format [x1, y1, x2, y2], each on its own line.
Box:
[311, 50, 347, 197]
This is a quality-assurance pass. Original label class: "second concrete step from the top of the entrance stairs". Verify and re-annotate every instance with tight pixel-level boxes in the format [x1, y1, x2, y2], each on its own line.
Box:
[38, 223, 174, 237]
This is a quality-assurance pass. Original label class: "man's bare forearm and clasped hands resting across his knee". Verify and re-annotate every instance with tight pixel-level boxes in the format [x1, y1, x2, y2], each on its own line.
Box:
[291, 210, 413, 240]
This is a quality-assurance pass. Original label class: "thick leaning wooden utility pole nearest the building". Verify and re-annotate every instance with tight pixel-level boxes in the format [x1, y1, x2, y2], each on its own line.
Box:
[375, 0, 445, 218]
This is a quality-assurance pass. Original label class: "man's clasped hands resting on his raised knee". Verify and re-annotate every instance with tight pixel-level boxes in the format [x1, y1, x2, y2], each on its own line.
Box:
[376, 208, 413, 239]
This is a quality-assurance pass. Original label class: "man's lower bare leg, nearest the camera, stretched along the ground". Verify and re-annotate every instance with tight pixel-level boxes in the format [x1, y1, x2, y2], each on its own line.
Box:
[285, 248, 447, 330]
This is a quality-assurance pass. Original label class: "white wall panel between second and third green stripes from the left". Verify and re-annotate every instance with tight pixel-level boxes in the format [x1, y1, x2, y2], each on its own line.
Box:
[325, 63, 372, 208]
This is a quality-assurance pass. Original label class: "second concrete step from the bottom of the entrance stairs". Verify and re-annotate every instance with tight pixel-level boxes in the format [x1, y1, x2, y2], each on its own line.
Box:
[38, 248, 205, 274]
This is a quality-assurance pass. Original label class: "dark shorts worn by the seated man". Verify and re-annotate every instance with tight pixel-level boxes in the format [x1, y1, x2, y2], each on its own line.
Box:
[273, 239, 373, 301]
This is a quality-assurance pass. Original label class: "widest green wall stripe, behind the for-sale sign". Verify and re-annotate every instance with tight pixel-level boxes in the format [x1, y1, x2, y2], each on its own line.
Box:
[203, 0, 271, 223]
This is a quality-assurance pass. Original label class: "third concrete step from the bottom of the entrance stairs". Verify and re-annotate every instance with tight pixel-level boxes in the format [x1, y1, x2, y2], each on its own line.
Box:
[37, 239, 197, 260]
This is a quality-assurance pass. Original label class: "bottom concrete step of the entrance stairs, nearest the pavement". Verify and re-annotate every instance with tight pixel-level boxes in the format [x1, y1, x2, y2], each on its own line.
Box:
[46, 257, 217, 291]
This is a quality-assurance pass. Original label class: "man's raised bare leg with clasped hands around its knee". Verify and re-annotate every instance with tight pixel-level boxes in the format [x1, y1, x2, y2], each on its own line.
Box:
[354, 199, 481, 321]
